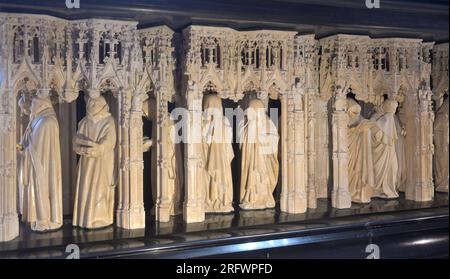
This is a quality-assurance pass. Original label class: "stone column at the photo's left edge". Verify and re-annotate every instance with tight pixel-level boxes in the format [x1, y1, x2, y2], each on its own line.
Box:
[0, 88, 19, 241]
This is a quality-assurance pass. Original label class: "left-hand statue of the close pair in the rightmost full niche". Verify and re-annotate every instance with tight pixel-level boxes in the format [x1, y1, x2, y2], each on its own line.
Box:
[347, 98, 375, 203]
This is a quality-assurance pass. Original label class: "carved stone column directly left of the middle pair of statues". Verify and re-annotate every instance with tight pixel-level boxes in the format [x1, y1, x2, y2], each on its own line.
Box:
[183, 83, 205, 223]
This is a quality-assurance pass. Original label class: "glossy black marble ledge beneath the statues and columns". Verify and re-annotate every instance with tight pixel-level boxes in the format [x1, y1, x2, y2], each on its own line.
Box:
[0, 194, 448, 258]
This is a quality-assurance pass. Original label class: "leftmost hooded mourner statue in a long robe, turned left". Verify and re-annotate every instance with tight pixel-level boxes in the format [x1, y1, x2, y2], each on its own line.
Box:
[19, 94, 63, 231]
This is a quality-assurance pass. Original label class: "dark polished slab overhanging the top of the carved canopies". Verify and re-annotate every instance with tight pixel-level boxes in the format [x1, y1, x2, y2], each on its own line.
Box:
[0, 0, 448, 42]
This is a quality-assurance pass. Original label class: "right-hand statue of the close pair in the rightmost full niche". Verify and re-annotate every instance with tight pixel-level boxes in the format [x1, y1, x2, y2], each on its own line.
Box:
[371, 99, 398, 199]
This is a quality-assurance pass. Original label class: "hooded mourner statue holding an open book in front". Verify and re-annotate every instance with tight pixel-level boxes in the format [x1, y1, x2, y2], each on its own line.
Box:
[73, 96, 116, 229]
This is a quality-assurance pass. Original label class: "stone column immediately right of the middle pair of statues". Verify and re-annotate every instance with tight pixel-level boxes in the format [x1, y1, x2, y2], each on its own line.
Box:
[281, 94, 307, 214]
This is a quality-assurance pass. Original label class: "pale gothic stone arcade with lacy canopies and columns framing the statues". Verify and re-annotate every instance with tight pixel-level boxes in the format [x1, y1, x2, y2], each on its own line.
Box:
[0, 13, 448, 241]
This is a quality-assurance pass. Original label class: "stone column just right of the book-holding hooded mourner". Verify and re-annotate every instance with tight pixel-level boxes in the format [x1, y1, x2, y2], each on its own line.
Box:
[116, 90, 145, 229]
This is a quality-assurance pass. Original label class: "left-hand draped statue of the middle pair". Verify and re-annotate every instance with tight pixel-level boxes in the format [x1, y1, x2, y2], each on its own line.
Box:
[202, 95, 234, 212]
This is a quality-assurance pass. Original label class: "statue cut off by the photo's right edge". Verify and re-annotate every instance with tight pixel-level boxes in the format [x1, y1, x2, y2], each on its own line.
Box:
[434, 97, 449, 193]
